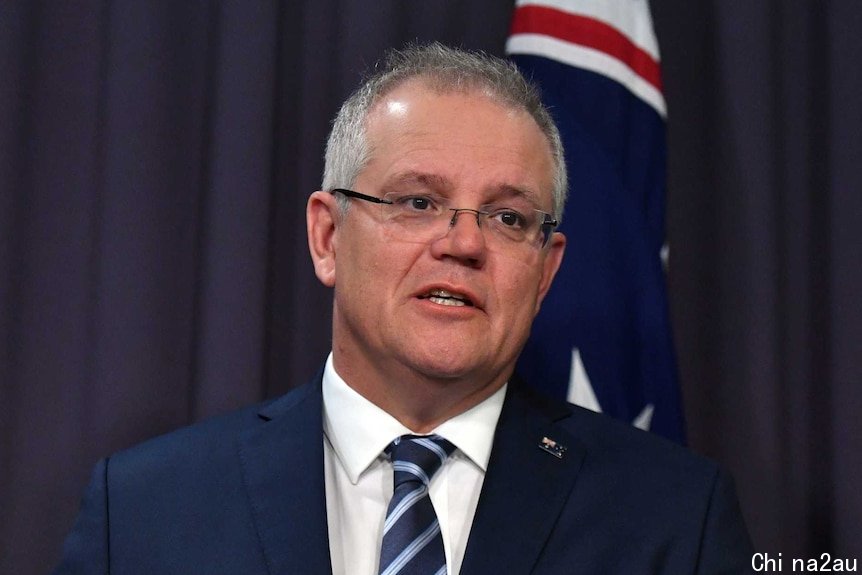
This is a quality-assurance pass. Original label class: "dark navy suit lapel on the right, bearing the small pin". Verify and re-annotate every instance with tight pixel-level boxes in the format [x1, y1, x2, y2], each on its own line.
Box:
[461, 382, 584, 575]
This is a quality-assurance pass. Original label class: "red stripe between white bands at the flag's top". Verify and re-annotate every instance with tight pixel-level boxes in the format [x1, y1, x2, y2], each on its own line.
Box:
[512, 6, 661, 91]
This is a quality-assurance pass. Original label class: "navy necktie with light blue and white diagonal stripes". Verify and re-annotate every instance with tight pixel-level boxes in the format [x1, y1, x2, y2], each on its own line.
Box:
[379, 435, 455, 575]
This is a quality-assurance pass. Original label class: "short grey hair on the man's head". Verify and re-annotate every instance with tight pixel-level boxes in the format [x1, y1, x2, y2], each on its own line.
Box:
[322, 42, 568, 223]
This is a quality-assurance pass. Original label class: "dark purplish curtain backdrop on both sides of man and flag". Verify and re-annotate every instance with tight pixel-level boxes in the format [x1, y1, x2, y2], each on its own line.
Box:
[0, 0, 862, 574]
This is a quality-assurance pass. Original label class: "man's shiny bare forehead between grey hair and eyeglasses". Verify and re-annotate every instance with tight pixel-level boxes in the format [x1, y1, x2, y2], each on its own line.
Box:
[357, 80, 554, 207]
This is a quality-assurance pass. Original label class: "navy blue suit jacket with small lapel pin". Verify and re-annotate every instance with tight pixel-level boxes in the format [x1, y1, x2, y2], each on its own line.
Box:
[57, 377, 752, 575]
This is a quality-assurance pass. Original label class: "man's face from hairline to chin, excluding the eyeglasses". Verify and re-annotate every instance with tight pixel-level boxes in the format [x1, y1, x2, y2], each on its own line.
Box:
[309, 81, 565, 400]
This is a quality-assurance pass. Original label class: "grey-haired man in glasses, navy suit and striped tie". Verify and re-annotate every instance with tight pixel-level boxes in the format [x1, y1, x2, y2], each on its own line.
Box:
[58, 45, 751, 575]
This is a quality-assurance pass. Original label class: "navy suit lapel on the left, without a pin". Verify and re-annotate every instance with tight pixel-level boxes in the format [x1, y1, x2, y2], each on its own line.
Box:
[239, 376, 332, 575]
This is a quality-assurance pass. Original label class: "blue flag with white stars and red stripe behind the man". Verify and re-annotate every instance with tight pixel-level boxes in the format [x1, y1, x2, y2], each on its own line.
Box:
[506, 0, 684, 442]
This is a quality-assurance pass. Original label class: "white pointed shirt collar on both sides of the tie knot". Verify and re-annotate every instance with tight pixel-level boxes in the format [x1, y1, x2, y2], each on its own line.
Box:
[323, 353, 508, 485]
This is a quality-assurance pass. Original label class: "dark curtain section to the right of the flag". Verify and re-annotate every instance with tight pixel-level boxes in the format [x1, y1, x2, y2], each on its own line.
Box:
[654, 1, 862, 557]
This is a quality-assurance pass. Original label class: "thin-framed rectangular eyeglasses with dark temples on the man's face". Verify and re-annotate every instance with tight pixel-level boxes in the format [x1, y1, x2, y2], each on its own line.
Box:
[330, 188, 558, 249]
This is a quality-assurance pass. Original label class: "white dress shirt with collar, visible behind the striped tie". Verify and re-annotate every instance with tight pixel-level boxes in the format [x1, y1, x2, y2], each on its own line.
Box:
[323, 354, 506, 575]
